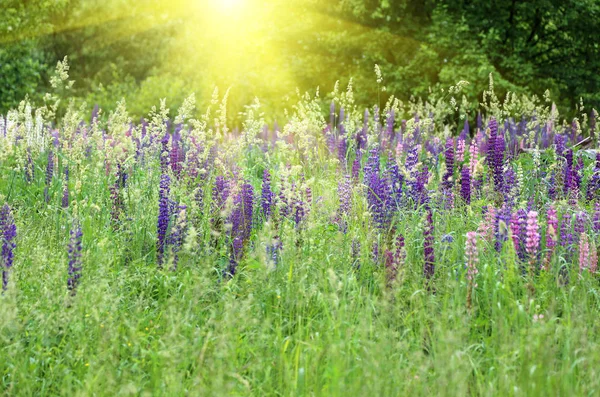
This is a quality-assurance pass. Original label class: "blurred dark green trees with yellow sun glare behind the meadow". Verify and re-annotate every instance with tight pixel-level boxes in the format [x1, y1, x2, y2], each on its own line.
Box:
[0, 0, 600, 123]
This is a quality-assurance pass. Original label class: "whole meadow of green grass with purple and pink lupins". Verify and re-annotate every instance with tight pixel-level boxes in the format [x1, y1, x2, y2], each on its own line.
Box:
[0, 62, 600, 396]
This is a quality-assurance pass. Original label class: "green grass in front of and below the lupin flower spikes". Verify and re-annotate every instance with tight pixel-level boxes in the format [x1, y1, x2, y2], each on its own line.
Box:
[0, 145, 600, 396]
